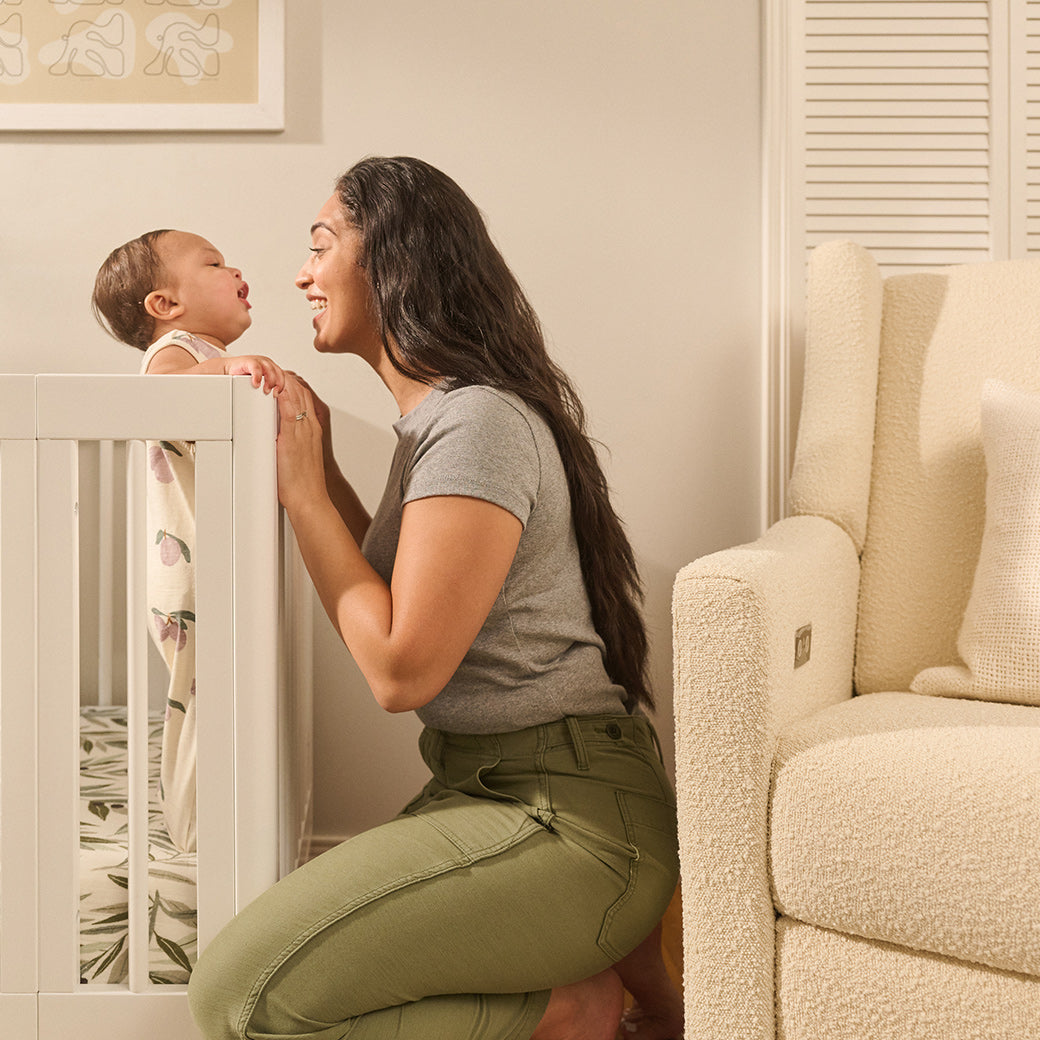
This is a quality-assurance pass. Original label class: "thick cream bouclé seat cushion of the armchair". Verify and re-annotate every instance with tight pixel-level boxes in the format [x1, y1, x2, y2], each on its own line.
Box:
[770, 693, 1040, 976]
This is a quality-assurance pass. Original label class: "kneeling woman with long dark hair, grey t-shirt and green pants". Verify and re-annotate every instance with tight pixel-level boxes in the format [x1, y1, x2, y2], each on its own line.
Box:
[190, 158, 681, 1040]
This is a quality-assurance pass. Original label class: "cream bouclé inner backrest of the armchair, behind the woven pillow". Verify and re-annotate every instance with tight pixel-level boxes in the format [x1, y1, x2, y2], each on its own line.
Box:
[856, 260, 1040, 693]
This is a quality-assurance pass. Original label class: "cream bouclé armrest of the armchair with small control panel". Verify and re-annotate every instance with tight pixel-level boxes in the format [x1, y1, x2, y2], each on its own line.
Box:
[673, 516, 859, 1040]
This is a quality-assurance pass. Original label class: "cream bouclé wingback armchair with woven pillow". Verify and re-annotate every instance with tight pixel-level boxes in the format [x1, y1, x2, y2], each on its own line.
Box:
[674, 242, 1040, 1040]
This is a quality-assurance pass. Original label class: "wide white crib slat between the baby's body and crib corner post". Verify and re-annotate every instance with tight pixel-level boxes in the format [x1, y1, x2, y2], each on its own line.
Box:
[194, 442, 236, 952]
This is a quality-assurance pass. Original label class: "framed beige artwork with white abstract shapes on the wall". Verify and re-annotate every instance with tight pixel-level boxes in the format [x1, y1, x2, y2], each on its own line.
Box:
[0, 0, 285, 131]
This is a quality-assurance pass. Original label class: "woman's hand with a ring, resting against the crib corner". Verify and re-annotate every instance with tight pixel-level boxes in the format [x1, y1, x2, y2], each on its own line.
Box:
[278, 373, 329, 516]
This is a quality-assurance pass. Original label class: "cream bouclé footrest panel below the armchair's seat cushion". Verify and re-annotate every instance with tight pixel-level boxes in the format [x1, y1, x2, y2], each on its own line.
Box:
[777, 917, 1040, 1040]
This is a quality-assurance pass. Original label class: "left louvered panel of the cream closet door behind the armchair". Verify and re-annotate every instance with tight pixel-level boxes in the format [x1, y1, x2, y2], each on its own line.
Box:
[790, 0, 1006, 271]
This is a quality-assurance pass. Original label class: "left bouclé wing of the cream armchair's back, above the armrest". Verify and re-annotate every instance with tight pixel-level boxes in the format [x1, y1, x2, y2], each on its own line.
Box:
[787, 241, 881, 551]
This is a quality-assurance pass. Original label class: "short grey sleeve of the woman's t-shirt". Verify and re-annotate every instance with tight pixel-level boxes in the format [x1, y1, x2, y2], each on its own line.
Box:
[401, 387, 541, 526]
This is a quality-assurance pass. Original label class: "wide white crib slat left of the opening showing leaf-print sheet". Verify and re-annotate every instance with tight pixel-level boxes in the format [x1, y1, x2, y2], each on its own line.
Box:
[36, 441, 79, 992]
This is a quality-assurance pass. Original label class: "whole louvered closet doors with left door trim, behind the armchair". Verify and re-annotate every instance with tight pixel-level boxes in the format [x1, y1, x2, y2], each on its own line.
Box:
[762, 0, 1040, 521]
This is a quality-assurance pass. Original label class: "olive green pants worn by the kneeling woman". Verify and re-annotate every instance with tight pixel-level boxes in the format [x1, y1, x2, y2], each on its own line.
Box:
[188, 716, 678, 1040]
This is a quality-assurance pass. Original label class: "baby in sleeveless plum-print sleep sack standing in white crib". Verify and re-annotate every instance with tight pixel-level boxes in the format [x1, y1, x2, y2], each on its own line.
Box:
[92, 231, 285, 852]
